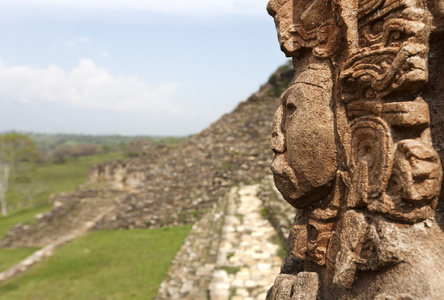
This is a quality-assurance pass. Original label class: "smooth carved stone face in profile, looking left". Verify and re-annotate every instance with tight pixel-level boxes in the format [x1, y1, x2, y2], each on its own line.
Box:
[271, 56, 337, 208]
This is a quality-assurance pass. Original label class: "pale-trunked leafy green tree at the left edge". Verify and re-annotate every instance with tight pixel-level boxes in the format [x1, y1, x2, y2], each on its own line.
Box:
[0, 132, 37, 216]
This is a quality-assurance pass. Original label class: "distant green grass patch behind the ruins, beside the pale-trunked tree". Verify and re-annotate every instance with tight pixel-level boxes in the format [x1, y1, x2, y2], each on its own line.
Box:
[6, 151, 123, 212]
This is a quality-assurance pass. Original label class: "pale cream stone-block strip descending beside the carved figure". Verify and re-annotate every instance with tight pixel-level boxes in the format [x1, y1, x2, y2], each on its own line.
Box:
[209, 185, 282, 300]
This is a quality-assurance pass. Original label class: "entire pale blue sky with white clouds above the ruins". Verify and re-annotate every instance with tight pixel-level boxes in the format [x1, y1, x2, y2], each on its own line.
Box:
[0, 0, 286, 136]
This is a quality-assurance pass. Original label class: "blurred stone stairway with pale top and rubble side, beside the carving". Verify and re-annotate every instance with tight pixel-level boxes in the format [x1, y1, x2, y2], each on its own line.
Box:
[156, 178, 293, 300]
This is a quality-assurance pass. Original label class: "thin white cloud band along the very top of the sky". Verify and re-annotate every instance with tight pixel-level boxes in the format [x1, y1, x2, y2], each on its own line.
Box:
[0, 0, 267, 15]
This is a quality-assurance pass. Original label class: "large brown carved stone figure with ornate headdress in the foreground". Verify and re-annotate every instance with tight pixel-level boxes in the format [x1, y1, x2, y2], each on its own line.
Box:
[267, 0, 444, 300]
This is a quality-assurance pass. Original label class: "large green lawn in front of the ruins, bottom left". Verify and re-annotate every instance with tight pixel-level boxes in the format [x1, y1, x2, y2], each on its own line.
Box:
[0, 226, 191, 300]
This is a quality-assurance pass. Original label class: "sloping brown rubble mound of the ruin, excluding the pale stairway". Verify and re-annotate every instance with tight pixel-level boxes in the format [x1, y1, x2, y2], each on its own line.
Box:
[1, 62, 293, 247]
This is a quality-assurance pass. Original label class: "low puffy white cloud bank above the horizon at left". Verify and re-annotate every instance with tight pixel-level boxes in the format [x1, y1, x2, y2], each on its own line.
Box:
[0, 59, 183, 113]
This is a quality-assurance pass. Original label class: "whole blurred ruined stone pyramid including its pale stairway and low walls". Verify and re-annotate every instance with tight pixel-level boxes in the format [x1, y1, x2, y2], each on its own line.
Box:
[0, 64, 295, 290]
